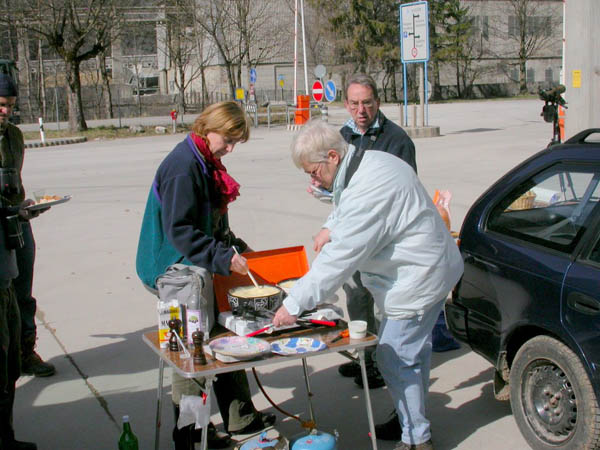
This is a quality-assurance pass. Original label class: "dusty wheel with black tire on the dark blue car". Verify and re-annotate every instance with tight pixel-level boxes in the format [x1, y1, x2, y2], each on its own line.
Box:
[510, 336, 600, 450]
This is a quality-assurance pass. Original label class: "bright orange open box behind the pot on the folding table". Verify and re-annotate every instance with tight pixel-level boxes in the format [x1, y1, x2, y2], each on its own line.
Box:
[214, 246, 309, 312]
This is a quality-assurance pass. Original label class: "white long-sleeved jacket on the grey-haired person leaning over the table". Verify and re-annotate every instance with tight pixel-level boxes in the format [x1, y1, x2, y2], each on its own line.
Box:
[283, 146, 463, 320]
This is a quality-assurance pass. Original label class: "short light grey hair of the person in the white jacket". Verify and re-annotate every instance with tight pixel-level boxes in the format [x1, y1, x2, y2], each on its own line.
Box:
[291, 119, 348, 169]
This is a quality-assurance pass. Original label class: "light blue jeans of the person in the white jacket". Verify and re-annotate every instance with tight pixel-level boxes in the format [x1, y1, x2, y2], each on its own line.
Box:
[377, 299, 444, 445]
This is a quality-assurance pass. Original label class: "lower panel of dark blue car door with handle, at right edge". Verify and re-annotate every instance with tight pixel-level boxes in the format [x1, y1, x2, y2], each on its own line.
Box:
[562, 221, 600, 397]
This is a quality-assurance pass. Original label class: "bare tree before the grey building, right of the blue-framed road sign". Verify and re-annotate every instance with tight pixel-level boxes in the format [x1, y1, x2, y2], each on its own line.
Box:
[491, 0, 563, 94]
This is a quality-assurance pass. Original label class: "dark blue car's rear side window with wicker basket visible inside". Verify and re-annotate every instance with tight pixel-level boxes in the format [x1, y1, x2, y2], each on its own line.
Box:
[487, 163, 600, 252]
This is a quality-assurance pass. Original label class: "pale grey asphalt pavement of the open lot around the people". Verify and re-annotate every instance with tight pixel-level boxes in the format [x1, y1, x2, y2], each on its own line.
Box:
[14, 100, 552, 450]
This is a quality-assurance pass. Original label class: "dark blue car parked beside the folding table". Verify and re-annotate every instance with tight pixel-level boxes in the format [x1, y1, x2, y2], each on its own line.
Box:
[446, 129, 600, 449]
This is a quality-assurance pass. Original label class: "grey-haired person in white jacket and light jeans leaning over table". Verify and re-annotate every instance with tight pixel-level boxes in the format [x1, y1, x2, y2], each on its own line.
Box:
[273, 121, 463, 450]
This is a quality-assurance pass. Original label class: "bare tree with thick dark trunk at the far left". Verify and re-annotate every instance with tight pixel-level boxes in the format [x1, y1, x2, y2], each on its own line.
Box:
[0, 0, 126, 131]
